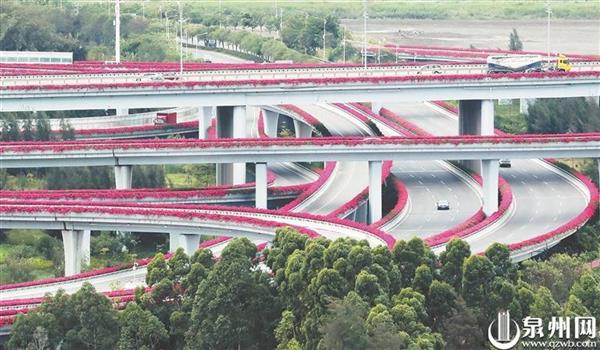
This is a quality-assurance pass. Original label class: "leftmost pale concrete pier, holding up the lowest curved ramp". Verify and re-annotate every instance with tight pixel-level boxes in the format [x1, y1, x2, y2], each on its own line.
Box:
[62, 230, 91, 276]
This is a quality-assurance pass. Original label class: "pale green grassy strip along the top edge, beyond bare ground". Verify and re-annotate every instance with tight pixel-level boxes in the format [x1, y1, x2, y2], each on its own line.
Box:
[155, 0, 600, 20]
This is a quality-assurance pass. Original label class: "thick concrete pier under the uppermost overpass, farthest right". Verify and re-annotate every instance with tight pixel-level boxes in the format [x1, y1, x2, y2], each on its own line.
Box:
[458, 100, 494, 174]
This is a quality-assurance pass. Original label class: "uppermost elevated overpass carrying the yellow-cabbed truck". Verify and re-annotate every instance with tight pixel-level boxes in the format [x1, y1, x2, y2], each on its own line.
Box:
[0, 70, 600, 112]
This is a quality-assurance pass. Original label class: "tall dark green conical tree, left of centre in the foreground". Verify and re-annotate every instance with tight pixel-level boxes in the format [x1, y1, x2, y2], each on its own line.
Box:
[186, 239, 281, 349]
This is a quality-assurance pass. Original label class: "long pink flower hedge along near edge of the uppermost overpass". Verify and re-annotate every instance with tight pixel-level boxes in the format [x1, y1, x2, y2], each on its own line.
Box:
[0, 71, 600, 91]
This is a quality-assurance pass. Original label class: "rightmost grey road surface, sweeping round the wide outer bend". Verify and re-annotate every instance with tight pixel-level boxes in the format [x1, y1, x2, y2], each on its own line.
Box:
[386, 102, 587, 253]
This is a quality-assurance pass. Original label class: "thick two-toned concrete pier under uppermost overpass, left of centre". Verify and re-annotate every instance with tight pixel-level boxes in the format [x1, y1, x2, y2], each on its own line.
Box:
[216, 106, 246, 185]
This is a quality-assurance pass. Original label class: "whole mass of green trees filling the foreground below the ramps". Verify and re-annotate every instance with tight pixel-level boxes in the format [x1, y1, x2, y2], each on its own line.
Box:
[8, 228, 600, 349]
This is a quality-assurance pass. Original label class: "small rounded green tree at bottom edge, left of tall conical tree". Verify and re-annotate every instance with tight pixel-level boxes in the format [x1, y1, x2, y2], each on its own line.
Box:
[117, 303, 167, 350]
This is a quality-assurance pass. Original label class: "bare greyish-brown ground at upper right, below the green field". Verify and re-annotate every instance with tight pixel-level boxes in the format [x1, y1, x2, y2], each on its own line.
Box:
[342, 19, 600, 55]
